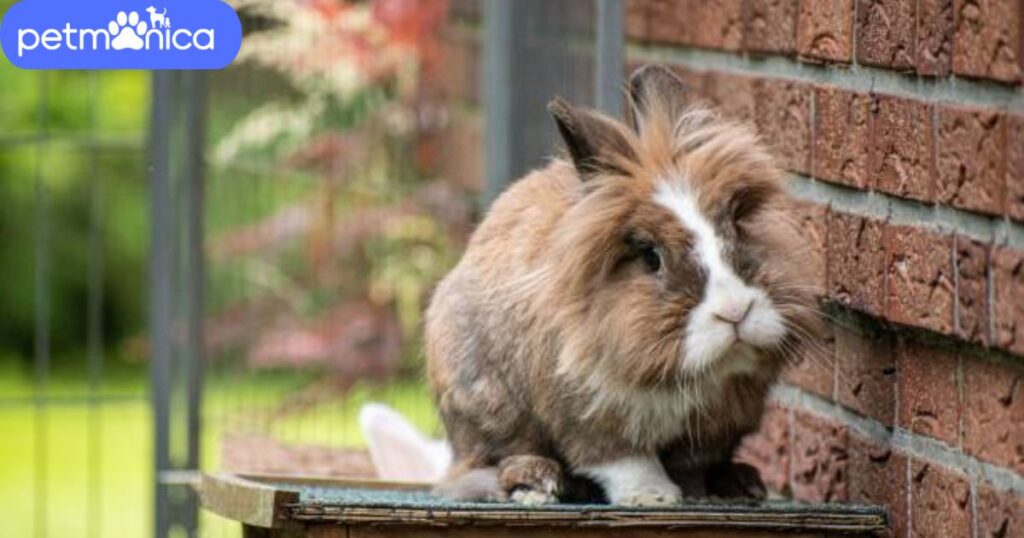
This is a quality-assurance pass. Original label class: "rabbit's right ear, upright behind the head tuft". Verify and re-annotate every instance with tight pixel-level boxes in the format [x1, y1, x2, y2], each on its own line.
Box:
[626, 65, 692, 132]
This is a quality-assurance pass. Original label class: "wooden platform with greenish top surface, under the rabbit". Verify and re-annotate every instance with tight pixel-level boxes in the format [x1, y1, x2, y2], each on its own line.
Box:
[199, 474, 886, 538]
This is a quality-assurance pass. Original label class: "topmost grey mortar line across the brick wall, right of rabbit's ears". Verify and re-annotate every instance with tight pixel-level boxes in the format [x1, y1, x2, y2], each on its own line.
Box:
[627, 43, 1024, 113]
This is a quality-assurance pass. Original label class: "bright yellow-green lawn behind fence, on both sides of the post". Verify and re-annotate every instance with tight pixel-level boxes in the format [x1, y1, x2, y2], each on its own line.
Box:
[0, 368, 438, 537]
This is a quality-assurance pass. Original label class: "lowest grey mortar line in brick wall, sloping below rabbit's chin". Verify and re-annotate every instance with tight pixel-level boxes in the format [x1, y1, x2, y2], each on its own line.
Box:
[772, 384, 1024, 495]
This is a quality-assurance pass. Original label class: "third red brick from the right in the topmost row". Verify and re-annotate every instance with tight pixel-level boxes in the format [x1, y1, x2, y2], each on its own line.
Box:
[857, 0, 916, 70]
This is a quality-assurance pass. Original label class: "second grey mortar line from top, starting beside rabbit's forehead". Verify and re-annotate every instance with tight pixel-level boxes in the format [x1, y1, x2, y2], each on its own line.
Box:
[787, 173, 1024, 249]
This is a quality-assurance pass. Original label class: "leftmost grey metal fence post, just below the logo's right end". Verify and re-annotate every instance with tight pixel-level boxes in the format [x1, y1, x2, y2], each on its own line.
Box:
[148, 71, 206, 538]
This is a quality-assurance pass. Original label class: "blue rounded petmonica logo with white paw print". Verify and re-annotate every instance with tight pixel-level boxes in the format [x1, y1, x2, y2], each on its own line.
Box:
[0, 0, 242, 69]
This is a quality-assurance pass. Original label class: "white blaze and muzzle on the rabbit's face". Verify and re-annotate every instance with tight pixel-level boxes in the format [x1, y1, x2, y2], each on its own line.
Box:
[654, 181, 785, 370]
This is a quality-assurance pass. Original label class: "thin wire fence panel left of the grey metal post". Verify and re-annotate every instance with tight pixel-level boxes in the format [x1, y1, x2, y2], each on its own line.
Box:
[0, 71, 152, 536]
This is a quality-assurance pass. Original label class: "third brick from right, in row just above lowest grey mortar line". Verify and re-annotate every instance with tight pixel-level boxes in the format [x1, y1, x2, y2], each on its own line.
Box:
[836, 327, 896, 426]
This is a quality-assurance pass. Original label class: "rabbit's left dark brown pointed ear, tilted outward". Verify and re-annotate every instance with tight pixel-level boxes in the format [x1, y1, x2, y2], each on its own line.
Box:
[548, 97, 635, 180]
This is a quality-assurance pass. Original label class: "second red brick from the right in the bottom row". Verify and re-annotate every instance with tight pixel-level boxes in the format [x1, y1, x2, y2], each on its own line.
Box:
[910, 460, 971, 538]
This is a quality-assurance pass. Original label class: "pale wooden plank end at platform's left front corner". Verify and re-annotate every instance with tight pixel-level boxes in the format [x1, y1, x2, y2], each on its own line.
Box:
[199, 473, 299, 528]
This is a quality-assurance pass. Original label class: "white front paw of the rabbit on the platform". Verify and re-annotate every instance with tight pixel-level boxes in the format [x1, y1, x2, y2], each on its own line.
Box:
[577, 456, 682, 506]
